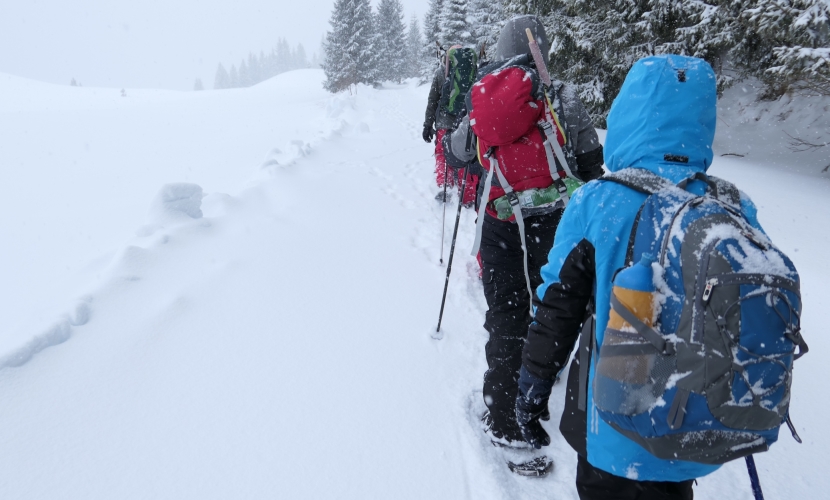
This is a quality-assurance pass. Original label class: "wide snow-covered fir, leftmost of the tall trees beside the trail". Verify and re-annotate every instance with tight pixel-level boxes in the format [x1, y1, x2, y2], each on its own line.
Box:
[323, 0, 377, 92]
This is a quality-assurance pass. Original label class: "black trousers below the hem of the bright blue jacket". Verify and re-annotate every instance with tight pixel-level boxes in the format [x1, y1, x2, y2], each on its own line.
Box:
[576, 455, 694, 500]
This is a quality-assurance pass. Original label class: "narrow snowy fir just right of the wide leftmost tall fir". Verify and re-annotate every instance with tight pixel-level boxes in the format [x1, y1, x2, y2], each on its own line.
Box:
[375, 0, 408, 83]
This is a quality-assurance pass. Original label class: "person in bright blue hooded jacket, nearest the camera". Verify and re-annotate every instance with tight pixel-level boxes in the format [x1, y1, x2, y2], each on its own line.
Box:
[516, 55, 772, 500]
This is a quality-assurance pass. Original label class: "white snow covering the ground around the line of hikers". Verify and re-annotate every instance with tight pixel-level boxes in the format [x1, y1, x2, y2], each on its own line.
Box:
[0, 70, 830, 500]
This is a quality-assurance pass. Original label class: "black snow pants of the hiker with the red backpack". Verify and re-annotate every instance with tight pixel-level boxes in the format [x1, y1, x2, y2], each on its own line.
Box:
[481, 210, 562, 441]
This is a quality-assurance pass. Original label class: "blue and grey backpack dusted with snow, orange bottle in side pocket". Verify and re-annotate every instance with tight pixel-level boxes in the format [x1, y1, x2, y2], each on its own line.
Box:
[593, 168, 808, 464]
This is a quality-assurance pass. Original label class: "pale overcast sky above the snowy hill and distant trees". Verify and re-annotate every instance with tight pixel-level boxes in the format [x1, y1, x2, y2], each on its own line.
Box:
[0, 0, 429, 90]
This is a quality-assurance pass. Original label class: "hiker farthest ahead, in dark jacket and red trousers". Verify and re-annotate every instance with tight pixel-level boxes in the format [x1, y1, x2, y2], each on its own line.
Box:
[423, 56, 478, 206]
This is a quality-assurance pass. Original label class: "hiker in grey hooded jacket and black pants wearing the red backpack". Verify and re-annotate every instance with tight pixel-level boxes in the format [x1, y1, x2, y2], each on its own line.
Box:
[445, 16, 602, 447]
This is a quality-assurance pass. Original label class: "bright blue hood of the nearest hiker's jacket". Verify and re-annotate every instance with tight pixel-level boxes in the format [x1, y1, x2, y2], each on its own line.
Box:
[605, 55, 717, 175]
